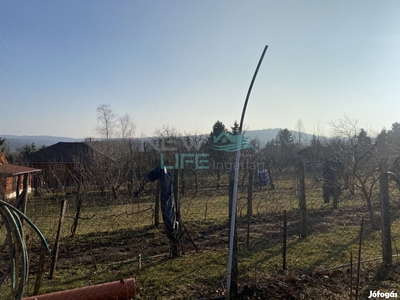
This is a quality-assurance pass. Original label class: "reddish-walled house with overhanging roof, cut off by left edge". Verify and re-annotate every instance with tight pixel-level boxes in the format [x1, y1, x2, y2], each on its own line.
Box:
[0, 152, 41, 200]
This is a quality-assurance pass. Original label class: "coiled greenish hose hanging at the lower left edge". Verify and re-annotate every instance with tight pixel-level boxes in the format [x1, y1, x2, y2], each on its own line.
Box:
[0, 200, 50, 300]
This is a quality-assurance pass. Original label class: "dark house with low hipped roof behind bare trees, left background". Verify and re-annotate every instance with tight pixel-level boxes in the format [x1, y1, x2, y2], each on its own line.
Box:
[28, 142, 110, 188]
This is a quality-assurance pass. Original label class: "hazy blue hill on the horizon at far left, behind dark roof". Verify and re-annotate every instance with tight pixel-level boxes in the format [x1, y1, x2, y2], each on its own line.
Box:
[0, 134, 83, 150]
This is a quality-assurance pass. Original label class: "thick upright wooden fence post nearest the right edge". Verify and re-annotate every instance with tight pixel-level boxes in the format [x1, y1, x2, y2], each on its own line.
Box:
[379, 161, 392, 266]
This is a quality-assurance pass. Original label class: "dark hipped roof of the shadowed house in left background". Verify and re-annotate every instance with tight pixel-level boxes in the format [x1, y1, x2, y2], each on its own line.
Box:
[28, 142, 105, 163]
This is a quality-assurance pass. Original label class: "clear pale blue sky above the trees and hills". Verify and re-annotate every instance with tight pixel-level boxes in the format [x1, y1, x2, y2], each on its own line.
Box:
[0, 0, 400, 138]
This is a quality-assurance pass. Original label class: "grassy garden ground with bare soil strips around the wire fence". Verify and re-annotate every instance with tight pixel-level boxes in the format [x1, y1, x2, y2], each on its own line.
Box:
[0, 172, 400, 300]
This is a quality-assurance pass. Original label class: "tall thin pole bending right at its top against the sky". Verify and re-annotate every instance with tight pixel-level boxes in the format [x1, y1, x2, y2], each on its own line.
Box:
[226, 45, 268, 299]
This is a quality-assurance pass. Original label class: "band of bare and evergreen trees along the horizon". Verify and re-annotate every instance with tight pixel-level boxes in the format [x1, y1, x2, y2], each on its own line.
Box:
[0, 104, 400, 216]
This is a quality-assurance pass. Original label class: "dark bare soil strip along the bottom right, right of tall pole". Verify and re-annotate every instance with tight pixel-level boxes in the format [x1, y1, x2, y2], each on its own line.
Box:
[197, 266, 400, 300]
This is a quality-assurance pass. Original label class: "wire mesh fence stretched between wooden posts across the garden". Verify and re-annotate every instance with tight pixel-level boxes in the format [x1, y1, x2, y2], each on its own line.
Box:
[0, 155, 400, 300]
